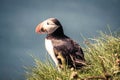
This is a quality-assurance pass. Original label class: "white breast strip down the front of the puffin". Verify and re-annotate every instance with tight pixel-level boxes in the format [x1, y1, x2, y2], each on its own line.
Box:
[45, 39, 58, 66]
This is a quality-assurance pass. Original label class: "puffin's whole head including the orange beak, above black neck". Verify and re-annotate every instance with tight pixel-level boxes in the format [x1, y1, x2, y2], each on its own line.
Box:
[35, 18, 61, 34]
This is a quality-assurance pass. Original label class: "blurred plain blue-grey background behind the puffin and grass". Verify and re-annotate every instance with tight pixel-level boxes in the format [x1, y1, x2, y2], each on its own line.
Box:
[0, 0, 120, 80]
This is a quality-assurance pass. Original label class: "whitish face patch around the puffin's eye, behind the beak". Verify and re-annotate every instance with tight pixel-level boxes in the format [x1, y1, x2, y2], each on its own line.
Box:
[43, 20, 59, 34]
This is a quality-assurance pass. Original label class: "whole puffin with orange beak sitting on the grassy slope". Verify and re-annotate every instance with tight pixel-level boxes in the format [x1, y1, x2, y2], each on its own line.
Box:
[35, 18, 85, 69]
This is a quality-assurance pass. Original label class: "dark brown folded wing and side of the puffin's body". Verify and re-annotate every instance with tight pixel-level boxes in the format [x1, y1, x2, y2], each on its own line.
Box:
[53, 38, 85, 68]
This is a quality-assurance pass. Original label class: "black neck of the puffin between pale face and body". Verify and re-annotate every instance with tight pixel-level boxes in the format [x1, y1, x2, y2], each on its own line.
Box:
[47, 26, 67, 38]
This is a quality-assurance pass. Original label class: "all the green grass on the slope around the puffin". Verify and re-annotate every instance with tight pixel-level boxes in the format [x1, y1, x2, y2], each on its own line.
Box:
[26, 32, 120, 80]
